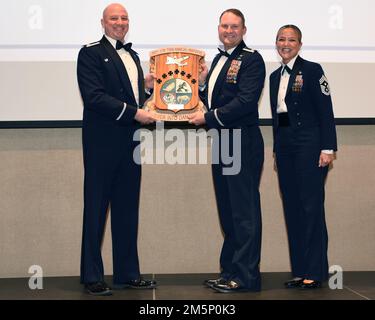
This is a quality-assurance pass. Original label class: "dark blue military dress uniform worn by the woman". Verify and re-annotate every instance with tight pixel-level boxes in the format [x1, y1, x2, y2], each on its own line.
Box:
[270, 56, 337, 281]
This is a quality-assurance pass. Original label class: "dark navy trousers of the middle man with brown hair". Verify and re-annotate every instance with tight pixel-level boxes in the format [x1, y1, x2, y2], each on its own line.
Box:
[212, 127, 264, 290]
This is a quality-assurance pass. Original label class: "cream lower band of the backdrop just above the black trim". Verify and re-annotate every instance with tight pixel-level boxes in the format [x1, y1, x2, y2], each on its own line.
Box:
[0, 61, 375, 121]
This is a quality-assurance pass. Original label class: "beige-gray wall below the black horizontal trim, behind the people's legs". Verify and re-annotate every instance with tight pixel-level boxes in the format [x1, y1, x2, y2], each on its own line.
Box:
[0, 126, 375, 277]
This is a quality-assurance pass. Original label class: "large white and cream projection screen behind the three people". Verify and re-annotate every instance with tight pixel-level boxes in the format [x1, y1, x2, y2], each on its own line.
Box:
[0, 0, 375, 123]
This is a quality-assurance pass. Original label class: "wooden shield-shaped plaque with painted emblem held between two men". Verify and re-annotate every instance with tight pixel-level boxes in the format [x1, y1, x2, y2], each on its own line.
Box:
[146, 47, 205, 121]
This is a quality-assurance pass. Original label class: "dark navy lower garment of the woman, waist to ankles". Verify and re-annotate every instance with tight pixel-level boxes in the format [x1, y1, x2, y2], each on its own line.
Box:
[275, 126, 328, 281]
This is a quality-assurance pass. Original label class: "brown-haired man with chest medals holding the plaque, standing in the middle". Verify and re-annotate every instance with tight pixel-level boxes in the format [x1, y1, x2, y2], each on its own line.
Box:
[189, 9, 265, 293]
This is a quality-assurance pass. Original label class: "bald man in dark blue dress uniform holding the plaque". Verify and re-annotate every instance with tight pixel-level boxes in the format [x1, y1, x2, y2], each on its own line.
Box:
[77, 4, 156, 295]
